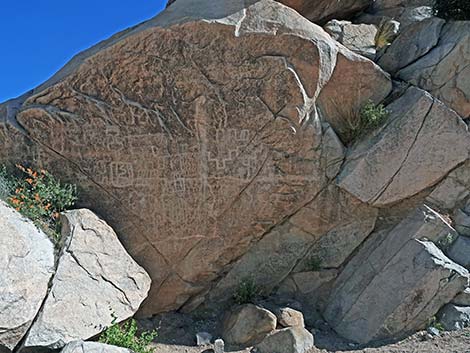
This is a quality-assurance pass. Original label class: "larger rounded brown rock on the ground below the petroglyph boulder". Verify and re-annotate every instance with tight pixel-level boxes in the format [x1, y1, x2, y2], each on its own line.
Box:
[223, 304, 277, 347]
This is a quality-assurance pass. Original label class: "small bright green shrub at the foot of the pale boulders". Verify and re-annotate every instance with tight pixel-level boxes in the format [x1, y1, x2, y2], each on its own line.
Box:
[99, 319, 157, 353]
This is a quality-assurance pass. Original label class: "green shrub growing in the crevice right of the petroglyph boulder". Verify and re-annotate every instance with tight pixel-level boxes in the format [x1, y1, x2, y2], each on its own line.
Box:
[347, 101, 389, 142]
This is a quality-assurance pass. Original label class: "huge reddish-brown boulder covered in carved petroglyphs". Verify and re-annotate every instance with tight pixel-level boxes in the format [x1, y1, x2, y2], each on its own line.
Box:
[0, 0, 391, 315]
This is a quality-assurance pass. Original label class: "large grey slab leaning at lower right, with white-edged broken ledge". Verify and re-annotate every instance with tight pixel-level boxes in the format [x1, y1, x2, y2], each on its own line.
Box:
[324, 208, 469, 343]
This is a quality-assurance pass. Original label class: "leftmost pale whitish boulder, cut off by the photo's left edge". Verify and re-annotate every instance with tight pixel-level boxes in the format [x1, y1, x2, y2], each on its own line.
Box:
[0, 201, 54, 352]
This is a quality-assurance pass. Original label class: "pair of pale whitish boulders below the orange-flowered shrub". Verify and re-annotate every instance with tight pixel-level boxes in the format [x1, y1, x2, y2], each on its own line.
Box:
[0, 201, 150, 352]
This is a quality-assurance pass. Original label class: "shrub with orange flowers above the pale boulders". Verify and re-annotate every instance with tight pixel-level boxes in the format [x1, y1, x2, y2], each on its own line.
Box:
[0, 165, 77, 241]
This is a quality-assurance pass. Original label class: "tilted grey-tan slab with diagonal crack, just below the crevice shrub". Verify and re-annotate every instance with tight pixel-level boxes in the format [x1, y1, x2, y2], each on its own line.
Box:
[337, 88, 470, 207]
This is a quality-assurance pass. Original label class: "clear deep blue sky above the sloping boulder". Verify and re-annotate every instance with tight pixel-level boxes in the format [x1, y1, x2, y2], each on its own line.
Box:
[0, 0, 166, 102]
